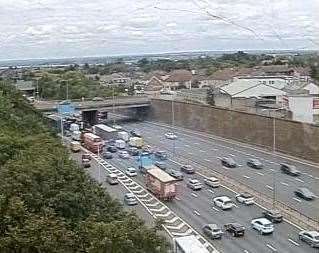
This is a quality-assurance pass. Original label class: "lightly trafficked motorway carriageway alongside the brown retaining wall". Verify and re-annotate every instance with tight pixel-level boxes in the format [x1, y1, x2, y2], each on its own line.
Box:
[120, 122, 319, 221]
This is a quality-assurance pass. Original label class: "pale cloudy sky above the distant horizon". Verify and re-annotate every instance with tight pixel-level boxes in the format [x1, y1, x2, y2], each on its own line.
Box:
[0, 0, 319, 60]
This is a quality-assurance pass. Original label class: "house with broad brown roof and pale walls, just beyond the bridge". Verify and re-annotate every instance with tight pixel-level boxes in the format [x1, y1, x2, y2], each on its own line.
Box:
[163, 69, 193, 90]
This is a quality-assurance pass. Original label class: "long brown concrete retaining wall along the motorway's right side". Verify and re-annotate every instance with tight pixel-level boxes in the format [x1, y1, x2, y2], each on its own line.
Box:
[149, 99, 319, 163]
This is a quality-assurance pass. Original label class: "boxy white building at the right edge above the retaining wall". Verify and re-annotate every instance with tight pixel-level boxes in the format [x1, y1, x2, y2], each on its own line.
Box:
[287, 95, 319, 124]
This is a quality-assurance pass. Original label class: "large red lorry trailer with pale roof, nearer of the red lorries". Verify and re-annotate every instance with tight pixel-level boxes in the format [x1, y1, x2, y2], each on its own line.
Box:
[146, 166, 177, 200]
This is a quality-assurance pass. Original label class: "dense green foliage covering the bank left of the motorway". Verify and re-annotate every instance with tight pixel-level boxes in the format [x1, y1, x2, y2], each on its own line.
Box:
[0, 83, 167, 253]
